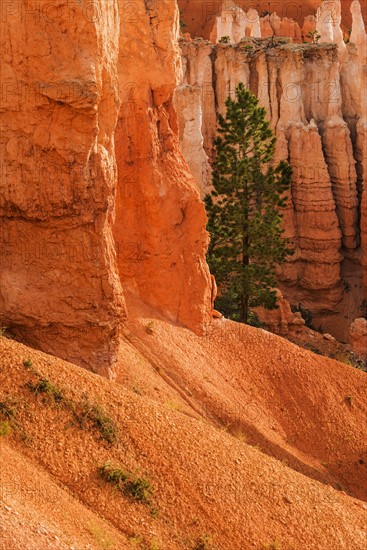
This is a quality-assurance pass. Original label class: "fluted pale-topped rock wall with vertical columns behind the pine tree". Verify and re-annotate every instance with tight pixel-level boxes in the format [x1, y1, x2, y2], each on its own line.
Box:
[177, 3, 366, 339]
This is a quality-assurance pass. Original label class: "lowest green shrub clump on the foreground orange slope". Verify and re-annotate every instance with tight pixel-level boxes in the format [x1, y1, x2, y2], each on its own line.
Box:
[98, 462, 153, 504]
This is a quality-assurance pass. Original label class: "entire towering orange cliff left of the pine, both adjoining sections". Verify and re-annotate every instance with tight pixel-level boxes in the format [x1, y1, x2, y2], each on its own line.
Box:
[0, 0, 211, 374]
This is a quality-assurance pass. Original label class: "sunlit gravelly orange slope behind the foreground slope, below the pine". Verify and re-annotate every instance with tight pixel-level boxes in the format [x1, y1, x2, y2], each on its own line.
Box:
[118, 297, 367, 499]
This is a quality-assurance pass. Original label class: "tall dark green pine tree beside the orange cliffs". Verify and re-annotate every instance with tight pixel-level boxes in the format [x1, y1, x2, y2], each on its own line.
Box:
[205, 83, 292, 323]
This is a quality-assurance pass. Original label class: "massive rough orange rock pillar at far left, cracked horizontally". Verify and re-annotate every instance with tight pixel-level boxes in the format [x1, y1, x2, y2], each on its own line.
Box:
[0, 0, 125, 372]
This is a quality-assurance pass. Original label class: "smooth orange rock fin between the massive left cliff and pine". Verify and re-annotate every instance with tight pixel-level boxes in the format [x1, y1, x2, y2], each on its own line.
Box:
[114, 0, 211, 332]
